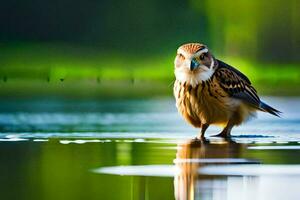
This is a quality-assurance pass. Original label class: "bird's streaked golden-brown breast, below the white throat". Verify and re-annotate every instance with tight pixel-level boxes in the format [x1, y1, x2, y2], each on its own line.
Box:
[174, 80, 230, 124]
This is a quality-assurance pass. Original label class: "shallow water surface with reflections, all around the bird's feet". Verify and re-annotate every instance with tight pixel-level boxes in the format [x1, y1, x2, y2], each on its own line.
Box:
[0, 98, 300, 200]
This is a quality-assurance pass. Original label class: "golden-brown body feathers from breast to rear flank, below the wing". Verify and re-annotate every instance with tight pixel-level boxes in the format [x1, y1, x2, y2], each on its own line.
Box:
[174, 72, 255, 127]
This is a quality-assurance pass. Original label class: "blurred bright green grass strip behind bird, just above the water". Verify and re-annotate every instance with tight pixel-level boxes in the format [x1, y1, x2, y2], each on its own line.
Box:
[0, 43, 300, 97]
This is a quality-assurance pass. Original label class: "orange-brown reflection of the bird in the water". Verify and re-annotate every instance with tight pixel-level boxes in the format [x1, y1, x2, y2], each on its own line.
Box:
[174, 139, 245, 200]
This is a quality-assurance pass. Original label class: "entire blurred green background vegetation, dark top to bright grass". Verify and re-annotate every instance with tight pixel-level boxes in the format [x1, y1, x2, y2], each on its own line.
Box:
[0, 0, 300, 97]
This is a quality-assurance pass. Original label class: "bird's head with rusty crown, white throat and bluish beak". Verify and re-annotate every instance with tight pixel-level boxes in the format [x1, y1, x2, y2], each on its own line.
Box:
[174, 43, 217, 86]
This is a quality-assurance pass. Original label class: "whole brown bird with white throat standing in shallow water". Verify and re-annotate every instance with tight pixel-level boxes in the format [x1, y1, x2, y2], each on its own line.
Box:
[173, 43, 281, 138]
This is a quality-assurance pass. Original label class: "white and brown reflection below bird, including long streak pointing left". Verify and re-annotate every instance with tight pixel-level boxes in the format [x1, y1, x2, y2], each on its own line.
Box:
[92, 140, 300, 200]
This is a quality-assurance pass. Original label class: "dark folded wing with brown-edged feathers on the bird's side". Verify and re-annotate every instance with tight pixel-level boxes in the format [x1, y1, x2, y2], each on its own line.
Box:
[215, 60, 260, 109]
